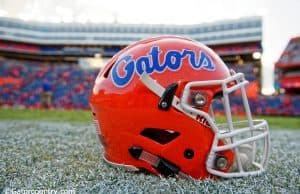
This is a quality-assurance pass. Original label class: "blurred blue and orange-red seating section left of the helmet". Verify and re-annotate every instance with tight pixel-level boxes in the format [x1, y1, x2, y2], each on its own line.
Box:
[0, 57, 97, 109]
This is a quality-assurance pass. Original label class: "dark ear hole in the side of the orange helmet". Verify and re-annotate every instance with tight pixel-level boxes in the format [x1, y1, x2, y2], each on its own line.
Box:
[141, 128, 180, 144]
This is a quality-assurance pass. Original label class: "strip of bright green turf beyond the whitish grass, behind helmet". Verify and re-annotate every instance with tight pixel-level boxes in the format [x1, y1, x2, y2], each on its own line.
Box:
[0, 108, 300, 130]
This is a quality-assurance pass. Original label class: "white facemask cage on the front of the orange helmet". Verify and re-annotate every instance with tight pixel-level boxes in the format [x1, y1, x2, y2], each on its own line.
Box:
[180, 73, 269, 178]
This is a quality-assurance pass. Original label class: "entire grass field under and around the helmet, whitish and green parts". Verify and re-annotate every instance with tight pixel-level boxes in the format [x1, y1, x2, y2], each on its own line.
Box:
[0, 109, 300, 193]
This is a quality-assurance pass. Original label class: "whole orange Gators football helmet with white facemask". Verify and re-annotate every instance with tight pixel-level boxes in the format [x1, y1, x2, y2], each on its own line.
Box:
[90, 36, 269, 179]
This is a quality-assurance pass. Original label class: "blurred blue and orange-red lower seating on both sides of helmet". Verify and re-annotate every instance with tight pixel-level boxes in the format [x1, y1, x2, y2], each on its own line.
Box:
[0, 59, 300, 115]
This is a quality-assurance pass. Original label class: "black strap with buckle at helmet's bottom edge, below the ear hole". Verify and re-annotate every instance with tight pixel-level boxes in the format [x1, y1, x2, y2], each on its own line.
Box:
[128, 146, 191, 179]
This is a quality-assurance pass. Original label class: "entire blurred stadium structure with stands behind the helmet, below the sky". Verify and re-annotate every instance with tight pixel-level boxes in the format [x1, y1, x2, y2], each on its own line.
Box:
[0, 16, 300, 116]
